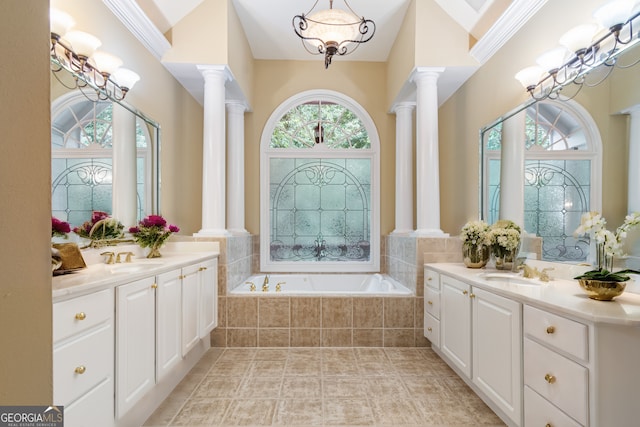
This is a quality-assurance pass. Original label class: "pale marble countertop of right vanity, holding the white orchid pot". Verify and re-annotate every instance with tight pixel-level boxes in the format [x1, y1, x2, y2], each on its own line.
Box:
[425, 263, 640, 326]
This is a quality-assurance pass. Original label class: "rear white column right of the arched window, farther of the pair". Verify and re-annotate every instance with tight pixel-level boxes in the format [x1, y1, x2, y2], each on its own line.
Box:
[393, 102, 415, 234]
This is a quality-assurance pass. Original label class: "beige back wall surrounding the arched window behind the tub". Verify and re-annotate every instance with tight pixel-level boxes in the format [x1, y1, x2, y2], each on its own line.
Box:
[245, 57, 395, 234]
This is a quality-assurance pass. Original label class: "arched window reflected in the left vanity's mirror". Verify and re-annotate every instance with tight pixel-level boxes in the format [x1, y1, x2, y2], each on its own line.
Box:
[51, 91, 152, 226]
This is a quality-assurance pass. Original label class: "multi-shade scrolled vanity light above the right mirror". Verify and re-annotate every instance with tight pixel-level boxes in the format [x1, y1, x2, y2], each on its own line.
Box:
[515, 0, 640, 101]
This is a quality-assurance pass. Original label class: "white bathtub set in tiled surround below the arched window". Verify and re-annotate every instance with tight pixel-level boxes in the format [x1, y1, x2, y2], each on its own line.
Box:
[230, 274, 413, 296]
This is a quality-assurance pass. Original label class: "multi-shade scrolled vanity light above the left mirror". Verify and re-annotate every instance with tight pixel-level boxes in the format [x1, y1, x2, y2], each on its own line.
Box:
[49, 9, 140, 101]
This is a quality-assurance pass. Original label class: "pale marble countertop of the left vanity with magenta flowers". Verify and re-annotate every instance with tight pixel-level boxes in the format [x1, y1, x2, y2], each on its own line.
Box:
[52, 242, 220, 303]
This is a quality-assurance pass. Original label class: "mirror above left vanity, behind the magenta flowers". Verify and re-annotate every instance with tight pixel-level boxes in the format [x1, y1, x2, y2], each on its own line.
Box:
[51, 60, 160, 228]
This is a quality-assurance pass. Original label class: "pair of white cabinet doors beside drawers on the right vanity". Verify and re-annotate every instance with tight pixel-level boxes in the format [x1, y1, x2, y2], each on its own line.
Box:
[435, 274, 522, 425]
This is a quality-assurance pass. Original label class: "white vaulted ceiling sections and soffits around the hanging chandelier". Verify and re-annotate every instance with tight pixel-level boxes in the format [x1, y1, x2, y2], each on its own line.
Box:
[124, 0, 528, 108]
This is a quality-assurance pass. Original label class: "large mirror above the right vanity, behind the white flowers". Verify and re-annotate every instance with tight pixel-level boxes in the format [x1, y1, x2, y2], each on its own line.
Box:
[479, 42, 640, 262]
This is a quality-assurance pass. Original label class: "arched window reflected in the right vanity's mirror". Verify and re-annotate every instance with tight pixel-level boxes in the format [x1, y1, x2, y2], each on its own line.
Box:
[483, 100, 602, 262]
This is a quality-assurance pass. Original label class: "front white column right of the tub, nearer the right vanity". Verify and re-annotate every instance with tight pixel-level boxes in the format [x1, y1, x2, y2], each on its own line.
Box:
[412, 67, 448, 237]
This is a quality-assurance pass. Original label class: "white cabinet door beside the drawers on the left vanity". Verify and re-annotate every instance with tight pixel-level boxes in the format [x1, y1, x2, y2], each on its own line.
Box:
[116, 278, 156, 418]
